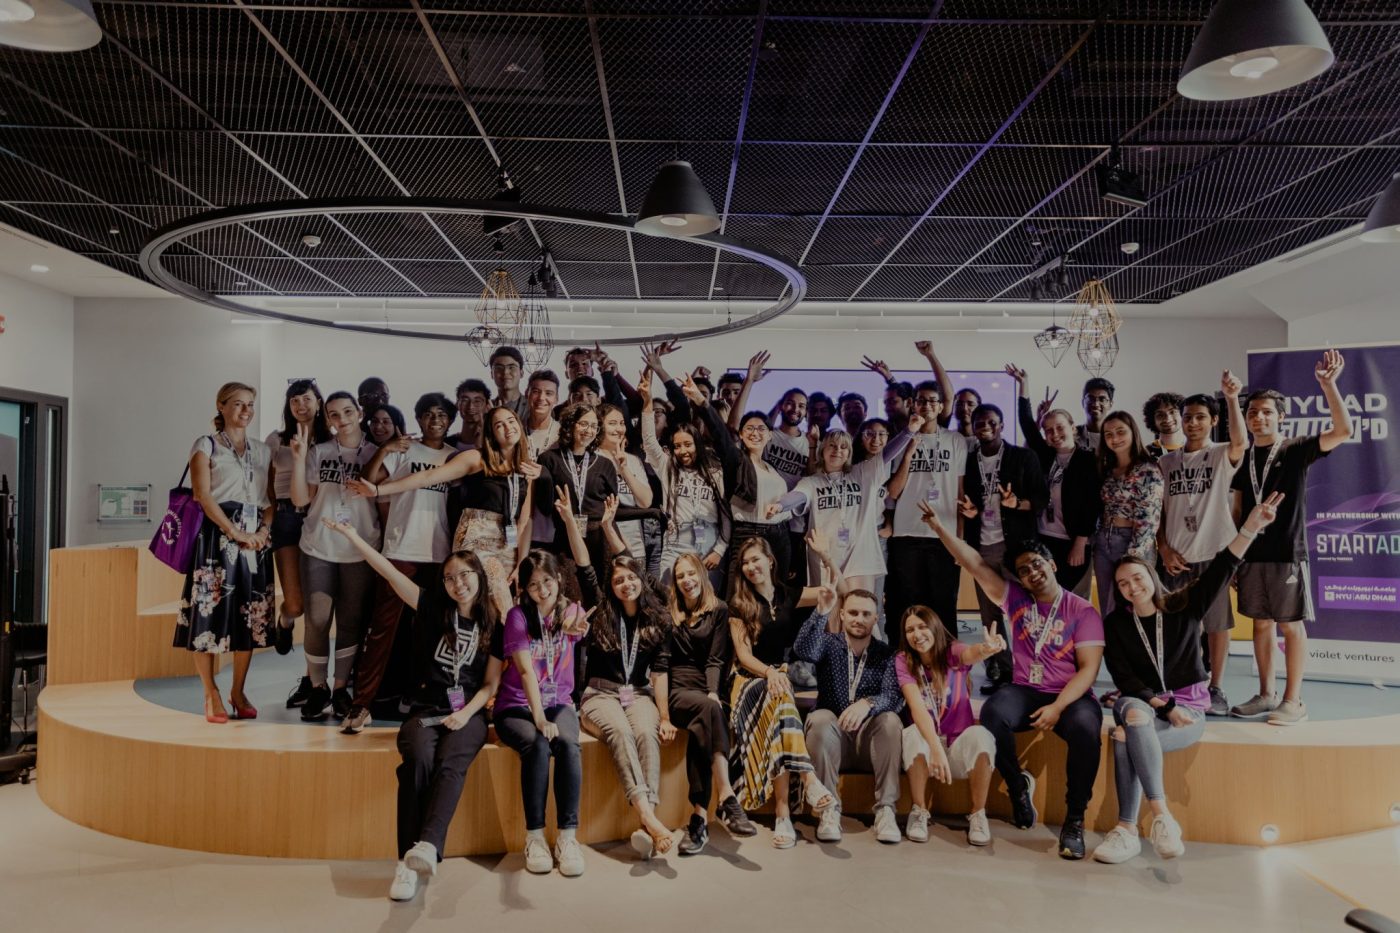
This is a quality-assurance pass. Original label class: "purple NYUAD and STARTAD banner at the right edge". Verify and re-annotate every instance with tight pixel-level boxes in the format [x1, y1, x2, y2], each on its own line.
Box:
[1249, 346, 1400, 643]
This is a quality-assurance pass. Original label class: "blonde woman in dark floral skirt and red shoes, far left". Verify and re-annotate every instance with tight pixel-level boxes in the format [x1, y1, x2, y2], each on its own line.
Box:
[175, 382, 276, 723]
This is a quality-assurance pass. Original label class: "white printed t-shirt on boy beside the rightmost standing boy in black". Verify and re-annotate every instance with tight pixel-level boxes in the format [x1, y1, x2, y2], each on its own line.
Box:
[1158, 444, 1245, 563]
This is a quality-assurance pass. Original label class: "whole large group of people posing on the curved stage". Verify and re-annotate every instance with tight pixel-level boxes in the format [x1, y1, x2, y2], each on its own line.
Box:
[175, 340, 1351, 899]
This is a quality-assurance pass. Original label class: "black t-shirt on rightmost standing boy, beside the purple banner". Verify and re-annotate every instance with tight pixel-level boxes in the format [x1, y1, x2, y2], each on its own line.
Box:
[1231, 434, 1327, 563]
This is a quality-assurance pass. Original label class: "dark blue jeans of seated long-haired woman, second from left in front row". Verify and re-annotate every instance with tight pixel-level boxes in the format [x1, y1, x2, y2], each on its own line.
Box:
[496, 706, 584, 829]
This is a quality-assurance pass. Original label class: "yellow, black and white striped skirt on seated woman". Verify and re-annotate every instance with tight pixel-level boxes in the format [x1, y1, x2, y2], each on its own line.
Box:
[729, 671, 813, 810]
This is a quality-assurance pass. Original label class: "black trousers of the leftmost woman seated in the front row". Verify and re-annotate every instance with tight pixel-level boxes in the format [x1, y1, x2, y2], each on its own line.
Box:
[398, 712, 486, 859]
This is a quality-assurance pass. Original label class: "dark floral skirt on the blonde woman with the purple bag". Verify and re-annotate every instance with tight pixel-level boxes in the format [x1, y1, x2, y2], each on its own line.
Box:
[175, 502, 274, 654]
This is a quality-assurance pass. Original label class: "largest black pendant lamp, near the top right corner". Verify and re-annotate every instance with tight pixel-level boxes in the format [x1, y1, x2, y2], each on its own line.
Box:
[1176, 0, 1336, 101]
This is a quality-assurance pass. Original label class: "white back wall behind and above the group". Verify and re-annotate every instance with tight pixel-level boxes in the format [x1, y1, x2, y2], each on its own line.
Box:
[70, 298, 1288, 544]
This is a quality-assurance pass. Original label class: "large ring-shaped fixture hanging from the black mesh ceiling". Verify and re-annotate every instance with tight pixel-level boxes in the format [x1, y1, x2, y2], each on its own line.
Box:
[140, 198, 806, 346]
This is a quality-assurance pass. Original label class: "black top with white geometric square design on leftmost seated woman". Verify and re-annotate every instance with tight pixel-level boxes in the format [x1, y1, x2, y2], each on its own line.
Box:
[413, 581, 505, 714]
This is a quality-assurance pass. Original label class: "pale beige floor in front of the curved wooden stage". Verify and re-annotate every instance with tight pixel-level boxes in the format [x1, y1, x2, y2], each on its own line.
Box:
[0, 773, 1400, 933]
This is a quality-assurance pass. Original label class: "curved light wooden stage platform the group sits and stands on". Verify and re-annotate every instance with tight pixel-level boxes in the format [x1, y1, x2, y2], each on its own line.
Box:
[38, 548, 1400, 859]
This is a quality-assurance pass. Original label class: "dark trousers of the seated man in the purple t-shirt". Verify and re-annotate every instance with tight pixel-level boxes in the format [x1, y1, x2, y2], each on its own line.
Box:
[981, 684, 1103, 820]
